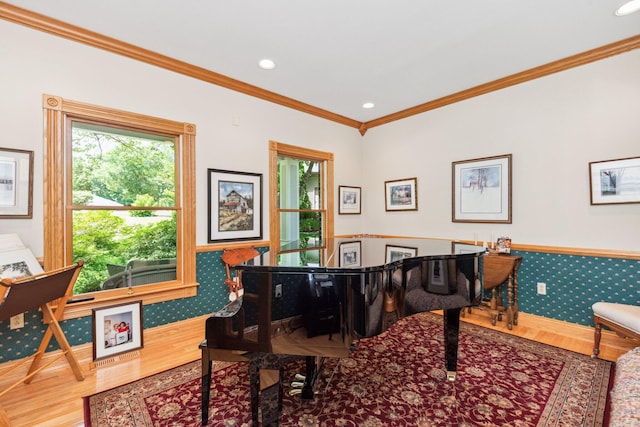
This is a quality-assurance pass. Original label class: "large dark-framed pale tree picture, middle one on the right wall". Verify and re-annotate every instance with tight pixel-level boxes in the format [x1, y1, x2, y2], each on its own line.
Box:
[452, 154, 511, 224]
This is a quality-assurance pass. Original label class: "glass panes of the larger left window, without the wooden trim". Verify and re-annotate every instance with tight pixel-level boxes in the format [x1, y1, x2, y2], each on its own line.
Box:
[71, 119, 178, 295]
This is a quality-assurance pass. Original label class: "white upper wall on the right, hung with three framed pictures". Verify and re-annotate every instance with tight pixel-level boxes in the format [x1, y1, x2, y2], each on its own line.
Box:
[362, 50, 640, 251]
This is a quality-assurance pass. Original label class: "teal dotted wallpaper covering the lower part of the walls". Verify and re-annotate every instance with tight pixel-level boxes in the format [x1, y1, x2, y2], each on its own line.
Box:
[0, 248, 640, 363]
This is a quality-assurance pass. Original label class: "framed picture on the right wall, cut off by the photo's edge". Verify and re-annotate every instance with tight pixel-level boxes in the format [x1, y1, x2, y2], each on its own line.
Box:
[589, 157, 640, 205]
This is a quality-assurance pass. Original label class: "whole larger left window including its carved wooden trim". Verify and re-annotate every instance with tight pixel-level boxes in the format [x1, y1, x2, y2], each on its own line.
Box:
[44, 95, 196, 318]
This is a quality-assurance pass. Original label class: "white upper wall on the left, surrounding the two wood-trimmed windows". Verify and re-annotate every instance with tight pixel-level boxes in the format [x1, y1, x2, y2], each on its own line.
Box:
[0, 20, 363, 256]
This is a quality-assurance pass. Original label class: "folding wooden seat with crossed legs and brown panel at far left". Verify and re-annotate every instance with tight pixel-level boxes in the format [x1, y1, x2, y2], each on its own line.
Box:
[0, 261, 84, 397]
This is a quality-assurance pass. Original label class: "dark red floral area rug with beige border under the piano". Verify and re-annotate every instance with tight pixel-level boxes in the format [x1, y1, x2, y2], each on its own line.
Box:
[85, 313, 613, 427]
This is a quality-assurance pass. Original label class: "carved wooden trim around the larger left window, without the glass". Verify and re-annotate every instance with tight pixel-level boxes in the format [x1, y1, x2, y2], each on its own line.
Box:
[42, 94, 198, 319]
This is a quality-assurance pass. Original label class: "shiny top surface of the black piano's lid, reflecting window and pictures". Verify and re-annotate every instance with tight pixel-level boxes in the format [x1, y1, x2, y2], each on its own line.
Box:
[244, 236, 485, 272]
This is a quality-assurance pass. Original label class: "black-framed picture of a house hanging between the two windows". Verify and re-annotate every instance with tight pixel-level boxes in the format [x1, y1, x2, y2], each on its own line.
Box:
[208, 169, 262, 243]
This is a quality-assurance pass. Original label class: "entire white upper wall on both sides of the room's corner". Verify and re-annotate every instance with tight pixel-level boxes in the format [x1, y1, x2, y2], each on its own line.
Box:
[0, 21, 640, 256]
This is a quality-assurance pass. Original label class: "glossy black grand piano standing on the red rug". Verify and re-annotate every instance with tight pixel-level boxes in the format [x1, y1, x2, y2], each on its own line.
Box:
[200, 236, 484, 425]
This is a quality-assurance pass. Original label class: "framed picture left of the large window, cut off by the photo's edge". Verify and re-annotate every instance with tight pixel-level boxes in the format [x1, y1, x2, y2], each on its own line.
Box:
[0, 148, 33, 219]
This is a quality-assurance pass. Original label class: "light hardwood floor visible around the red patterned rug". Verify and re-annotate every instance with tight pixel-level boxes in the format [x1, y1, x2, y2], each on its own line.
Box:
[0, 309, 640, 427]
